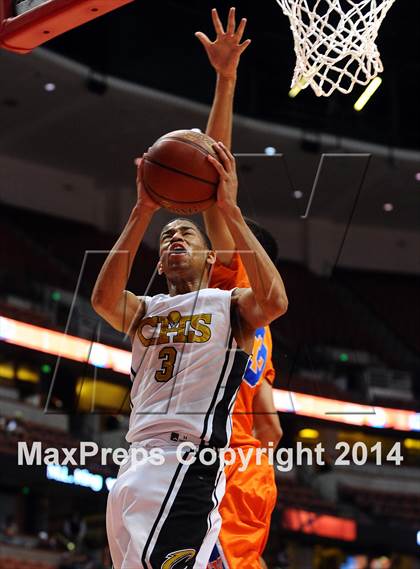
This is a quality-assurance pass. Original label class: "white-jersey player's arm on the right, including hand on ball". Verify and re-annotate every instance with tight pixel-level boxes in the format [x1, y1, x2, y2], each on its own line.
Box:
[207, 143, 288, 330]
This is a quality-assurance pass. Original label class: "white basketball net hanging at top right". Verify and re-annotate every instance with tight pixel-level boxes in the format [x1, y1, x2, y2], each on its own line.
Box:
[277, 0, 395, 97]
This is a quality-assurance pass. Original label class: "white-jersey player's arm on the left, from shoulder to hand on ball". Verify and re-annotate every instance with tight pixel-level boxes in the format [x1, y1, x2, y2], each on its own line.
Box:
[91, 164, 159, 333]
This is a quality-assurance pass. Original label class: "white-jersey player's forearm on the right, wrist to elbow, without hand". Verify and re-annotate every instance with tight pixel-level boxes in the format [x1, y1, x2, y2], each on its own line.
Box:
[220, 205, 288, 321]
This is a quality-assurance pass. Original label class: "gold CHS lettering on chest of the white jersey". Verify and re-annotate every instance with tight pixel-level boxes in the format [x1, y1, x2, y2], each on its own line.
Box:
[137, 310, 212, 348]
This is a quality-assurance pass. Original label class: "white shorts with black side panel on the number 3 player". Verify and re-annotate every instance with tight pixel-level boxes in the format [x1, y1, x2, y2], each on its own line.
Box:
[106, 439, 225, 569]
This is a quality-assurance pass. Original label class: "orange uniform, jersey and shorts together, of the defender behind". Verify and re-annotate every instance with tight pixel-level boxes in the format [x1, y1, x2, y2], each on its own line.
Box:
[207, 253, 277, 569]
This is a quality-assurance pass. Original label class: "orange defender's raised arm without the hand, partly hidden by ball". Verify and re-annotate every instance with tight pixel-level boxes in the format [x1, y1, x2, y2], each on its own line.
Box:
[203, 75, 236, 265]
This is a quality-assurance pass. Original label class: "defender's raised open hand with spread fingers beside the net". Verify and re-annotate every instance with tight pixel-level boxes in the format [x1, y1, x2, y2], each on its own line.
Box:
[195, 8, 251, 78]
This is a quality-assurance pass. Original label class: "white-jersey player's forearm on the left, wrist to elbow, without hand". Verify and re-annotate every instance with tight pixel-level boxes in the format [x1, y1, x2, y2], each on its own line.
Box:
[92, 204, 153, 308]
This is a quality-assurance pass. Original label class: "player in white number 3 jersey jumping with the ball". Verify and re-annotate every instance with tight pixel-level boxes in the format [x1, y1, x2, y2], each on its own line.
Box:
[92, 143, 287, 569]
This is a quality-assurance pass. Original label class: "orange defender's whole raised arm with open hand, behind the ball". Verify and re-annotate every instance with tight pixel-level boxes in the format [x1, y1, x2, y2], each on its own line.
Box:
[195, 8, 251, 265]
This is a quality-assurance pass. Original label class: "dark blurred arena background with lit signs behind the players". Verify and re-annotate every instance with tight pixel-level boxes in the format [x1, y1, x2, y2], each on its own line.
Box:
[0, 0, 420, 569]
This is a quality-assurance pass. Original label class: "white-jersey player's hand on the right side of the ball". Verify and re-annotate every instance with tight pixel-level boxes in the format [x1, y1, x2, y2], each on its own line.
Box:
[207, 142, 238, 211]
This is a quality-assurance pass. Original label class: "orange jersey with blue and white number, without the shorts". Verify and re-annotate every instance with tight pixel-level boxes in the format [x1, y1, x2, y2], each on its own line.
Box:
[209, 252, 275, 447]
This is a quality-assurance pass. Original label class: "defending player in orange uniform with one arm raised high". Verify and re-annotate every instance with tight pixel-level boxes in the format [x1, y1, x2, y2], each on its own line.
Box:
[196, 8, 282, 569]
